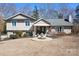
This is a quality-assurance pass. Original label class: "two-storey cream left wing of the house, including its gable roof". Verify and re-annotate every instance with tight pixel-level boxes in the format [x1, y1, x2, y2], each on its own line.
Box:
[6, 13, 35, 36]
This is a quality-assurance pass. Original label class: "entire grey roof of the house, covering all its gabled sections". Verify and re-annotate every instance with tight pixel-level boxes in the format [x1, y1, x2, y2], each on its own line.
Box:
[7, 13, 73, 26]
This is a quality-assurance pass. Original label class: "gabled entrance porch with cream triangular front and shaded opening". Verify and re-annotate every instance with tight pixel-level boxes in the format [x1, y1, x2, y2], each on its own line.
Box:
[33, 19, 51, 36]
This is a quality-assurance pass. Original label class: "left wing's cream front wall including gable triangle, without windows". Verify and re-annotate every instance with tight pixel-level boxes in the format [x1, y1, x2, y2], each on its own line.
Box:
[6, 15, 33, 31]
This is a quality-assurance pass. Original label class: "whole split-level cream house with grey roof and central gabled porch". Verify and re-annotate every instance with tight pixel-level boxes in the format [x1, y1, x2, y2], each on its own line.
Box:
[6, 13, 73, 36]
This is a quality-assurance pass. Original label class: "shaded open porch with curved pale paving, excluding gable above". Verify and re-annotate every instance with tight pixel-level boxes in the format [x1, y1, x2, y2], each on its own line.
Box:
[32, 26, 52, 41]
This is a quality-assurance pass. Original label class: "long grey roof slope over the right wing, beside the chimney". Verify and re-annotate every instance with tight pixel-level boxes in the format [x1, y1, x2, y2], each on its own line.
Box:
[46, 19, 73, 26]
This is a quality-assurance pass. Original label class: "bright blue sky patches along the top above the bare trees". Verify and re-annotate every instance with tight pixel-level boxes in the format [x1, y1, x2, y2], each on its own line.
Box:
[16, 3, 78, 9]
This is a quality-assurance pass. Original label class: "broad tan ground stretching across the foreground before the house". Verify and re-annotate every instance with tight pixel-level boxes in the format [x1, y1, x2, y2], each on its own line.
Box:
[0, 36, 79, 56]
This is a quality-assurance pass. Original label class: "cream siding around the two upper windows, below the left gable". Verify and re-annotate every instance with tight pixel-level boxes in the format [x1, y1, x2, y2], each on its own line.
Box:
[6, 22, 33, 31]
